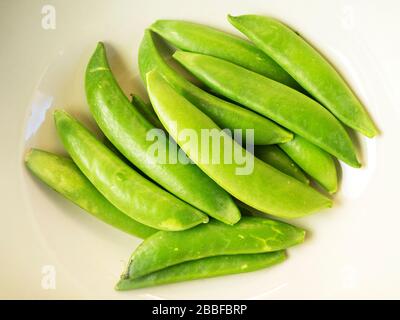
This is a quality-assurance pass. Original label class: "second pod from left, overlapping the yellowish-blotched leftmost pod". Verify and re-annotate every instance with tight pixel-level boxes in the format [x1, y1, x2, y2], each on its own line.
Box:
[54, 110, 208, 231]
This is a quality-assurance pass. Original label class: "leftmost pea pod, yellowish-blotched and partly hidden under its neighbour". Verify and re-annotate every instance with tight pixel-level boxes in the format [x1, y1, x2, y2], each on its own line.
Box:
[25, 149, 158, 238]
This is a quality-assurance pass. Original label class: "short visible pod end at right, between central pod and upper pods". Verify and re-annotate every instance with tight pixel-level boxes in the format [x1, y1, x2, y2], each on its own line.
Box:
[280, 135, 338, 193]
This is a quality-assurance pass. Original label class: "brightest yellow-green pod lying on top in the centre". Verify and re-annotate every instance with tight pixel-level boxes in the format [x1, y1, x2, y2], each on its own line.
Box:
[147, 70, 332, 218]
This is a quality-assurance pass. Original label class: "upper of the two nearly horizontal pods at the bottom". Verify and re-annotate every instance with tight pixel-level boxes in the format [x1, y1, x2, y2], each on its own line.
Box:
[121, 217, 305, 279]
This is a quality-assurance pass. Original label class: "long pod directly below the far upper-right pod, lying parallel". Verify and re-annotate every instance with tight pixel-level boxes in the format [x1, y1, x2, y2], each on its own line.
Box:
[174, 51, 360, 168]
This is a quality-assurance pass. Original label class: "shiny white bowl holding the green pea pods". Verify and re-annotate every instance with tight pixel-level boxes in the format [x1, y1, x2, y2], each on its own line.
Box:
[0, 0, 400, 299]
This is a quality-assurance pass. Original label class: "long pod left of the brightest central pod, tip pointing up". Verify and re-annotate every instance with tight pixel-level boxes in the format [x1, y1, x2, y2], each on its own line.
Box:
[85, 43, 240, 224]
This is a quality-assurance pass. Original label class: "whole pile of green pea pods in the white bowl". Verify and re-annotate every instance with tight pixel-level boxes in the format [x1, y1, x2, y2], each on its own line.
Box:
[26, 15, 378, 290]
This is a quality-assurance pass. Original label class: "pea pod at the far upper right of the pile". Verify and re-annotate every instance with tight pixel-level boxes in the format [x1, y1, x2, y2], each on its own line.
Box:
[228, 15, 378, 137]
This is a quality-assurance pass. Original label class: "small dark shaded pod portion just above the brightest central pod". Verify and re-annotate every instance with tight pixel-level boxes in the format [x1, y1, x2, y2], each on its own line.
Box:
[254, 145, 310, 184]
